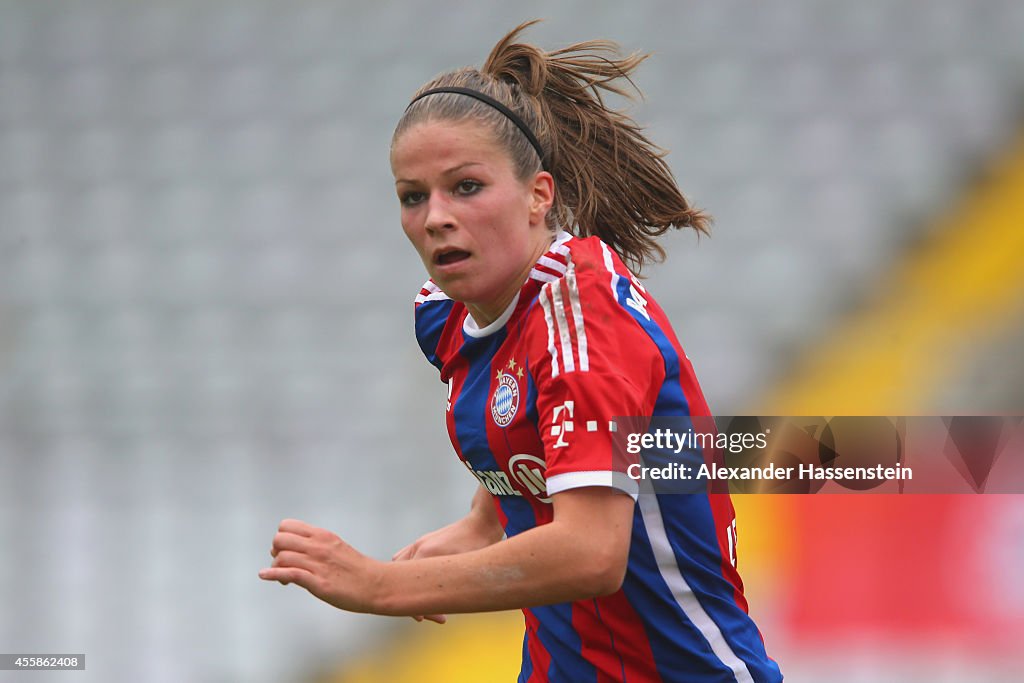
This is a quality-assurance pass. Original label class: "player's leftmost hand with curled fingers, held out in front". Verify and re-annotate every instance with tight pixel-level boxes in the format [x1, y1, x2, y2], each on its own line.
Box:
[259, 519, 378, 612]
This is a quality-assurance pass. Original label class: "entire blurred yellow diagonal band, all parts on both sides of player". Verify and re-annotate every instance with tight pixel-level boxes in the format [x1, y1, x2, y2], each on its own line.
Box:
[323, 129, 1024, 683]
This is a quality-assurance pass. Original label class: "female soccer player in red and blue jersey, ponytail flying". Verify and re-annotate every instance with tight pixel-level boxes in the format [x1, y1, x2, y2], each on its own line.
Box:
[260, 24, 781, 683]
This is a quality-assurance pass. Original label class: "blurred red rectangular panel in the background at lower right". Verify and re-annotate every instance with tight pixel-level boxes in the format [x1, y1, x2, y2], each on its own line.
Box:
[784, 495, 1024, 653]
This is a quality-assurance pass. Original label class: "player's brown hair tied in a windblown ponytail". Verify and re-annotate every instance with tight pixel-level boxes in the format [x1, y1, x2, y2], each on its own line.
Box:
[392, 19, 711, 272]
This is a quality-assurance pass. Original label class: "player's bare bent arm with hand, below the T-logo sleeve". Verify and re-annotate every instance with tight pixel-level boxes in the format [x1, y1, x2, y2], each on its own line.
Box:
[259, 486, 635, 616]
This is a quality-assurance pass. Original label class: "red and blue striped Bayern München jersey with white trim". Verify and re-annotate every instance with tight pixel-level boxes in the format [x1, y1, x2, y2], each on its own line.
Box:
[416, 232, 782, 683]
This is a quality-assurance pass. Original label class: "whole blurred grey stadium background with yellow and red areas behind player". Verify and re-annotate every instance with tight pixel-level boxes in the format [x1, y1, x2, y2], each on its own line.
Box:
[0, 0, 1024, 683]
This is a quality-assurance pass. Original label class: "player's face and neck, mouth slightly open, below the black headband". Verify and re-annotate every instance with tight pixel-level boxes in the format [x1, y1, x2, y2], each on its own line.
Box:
[391, 121, 554, 326]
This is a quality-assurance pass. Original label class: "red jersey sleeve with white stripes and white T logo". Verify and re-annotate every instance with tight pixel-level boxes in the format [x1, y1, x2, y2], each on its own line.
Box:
[529, 259, 665, 498]
